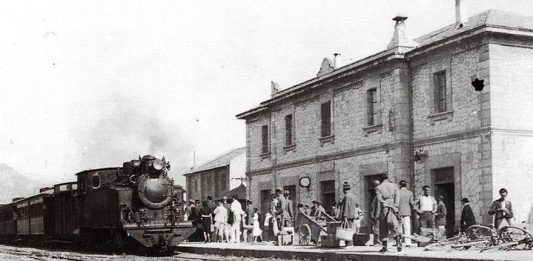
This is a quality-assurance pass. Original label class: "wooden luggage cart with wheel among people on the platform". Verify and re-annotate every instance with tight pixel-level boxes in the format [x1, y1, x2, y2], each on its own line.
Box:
[294, 210, 339, 245]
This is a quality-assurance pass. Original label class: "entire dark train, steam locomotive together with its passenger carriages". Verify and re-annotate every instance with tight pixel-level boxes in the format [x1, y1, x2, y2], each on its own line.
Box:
[0, 155, 195, 253]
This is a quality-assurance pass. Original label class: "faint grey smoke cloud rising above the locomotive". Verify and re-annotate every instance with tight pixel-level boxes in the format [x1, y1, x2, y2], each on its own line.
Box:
[69, 93, 192, 181]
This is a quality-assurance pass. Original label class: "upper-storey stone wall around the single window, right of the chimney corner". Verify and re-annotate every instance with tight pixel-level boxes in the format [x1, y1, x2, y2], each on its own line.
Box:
[411, 44, 485, 141]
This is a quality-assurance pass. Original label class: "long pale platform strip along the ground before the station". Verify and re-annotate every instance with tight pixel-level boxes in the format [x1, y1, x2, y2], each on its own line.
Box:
[178, 242, 533, 261]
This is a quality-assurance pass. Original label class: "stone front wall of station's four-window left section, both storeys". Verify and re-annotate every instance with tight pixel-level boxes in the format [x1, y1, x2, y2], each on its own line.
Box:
[247, 59, 411, 225]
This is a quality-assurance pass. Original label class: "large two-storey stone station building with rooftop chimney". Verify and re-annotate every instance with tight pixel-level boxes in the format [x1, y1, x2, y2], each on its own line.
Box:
[237, 6, 533, 233]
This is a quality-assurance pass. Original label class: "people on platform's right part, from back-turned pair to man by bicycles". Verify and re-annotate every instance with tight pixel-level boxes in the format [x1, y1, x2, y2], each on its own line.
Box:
[370, 174, 513, 252]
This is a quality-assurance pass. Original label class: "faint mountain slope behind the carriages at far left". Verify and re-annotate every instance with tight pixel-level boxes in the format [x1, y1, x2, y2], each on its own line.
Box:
[0, 163, 46, 204]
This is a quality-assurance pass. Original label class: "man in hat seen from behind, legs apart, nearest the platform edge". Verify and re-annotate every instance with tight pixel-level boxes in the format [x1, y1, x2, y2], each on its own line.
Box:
[376, 174, 402, 253]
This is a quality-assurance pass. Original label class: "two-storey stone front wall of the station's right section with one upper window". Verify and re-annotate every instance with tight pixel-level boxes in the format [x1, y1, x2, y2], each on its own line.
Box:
[411, 40, 492, 225]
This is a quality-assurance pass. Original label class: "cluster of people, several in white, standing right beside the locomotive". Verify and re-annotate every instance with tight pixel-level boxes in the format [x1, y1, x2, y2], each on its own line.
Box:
[185, 196, 262, 243]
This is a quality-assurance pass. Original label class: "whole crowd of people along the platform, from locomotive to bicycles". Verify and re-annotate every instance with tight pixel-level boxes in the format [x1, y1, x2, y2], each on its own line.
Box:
[186, 174, 513, 252]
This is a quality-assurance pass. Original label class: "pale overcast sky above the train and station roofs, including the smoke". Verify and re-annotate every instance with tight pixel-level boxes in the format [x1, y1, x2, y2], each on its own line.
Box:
[0, 0, 533, 183]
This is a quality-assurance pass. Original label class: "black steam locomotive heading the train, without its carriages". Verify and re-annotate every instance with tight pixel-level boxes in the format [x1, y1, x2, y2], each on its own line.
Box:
[75, 155, 195, 252]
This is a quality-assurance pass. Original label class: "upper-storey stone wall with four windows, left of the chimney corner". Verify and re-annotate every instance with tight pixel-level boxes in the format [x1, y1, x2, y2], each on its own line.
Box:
[247, 60, 410, 175]
